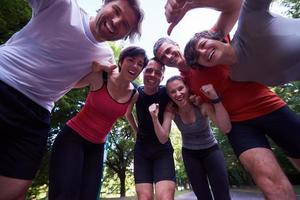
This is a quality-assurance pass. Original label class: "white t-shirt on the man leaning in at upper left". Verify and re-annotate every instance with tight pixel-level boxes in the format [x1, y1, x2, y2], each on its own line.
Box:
[0, 0, 113, 111]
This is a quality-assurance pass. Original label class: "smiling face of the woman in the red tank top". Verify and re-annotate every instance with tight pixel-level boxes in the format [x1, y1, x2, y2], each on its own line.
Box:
[120, 55, 145, 81]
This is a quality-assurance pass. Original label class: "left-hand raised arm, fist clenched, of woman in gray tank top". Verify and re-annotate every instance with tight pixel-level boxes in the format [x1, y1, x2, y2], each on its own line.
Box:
[149, 103, 174, 144]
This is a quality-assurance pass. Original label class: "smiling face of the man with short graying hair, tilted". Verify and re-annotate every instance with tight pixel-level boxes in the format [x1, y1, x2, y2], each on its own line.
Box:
[156, 42, 185, 68]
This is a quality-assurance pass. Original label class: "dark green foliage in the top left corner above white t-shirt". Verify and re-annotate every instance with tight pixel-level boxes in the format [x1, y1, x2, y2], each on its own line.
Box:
[0, 0, 31, 44]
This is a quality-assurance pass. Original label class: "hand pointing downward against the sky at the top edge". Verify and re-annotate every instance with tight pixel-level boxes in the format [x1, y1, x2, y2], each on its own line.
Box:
[165, 0, 191, 35]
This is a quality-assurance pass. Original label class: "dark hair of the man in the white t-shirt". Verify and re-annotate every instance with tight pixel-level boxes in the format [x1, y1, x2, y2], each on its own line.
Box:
[102, 0, 144, 41]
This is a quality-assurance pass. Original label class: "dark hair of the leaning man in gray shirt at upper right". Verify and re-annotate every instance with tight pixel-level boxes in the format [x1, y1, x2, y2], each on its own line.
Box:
[184, 31, 223, 68]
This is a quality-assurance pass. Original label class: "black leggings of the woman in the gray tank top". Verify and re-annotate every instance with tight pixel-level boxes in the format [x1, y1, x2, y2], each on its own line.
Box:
[182, 145, 230, 200]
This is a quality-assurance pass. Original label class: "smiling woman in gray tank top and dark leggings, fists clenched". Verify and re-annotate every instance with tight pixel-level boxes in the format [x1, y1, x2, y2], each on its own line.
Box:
[149, 76, 231, 200]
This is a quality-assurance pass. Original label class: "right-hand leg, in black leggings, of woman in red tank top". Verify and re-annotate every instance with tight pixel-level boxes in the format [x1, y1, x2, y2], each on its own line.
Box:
[80, 142, 104, 200]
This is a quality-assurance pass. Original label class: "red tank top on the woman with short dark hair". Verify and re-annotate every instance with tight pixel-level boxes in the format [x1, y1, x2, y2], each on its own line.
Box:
[67, 84, 135, 144]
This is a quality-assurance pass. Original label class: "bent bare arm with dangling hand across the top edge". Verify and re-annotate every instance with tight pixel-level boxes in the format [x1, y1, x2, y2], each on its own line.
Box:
[165, 0, 243, 35]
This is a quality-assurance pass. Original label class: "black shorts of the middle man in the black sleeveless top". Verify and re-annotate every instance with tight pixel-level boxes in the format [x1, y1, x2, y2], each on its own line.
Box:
[134, 141, 176, 184]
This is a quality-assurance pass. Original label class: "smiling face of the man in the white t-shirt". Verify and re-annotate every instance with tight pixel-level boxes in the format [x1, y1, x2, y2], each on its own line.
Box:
[90, 0, 139, 42]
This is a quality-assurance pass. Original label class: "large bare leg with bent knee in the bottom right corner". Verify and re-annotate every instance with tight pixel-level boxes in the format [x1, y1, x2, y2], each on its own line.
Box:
[239, 148, 296, 200]
